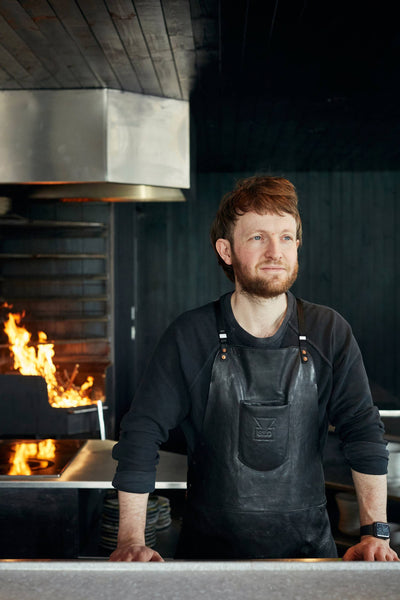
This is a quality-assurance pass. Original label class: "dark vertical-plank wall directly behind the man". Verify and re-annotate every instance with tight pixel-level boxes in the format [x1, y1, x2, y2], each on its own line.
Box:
[111, 171, 400, 434]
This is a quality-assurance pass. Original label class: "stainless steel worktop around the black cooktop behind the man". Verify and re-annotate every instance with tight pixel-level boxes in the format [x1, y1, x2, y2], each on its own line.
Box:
[0, 440, 187, 489]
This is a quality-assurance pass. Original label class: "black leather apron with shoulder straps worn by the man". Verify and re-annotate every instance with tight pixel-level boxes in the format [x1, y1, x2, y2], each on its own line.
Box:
[176, 300, 337, 559]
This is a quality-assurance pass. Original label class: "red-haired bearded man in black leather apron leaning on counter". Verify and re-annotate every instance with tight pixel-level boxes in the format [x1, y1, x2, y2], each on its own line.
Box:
[110, 177, 398, 561]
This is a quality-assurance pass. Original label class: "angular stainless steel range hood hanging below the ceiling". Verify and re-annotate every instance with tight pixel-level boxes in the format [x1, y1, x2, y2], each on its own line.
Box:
[0, 89, 190, 201]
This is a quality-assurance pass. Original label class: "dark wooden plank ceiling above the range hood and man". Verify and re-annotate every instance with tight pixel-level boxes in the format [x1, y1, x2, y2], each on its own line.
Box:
[0, 0, 400, 172]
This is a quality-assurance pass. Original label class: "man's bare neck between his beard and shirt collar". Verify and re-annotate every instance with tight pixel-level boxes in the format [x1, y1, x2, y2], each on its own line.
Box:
[231, 290, 287, 338]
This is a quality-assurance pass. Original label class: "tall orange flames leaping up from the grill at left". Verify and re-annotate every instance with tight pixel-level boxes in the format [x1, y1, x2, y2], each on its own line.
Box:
[4, 313, 94, 408]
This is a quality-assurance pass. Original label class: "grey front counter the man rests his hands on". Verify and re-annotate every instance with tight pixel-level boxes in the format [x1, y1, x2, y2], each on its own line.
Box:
[0, 560, 400, 600]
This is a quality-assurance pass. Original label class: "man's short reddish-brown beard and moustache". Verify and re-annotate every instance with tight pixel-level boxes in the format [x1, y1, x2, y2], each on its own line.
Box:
[232, 256, 299, 298]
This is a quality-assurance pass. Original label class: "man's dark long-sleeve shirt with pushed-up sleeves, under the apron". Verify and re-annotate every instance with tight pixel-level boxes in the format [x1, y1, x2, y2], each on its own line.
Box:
[113, 292, 388, 493]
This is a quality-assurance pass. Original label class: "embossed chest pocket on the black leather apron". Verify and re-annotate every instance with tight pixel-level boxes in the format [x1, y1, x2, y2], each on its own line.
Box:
[239, 402, 289, 471]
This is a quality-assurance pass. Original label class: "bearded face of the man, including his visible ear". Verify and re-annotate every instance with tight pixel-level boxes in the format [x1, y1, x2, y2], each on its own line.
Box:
[217, 212, 299, 298]
